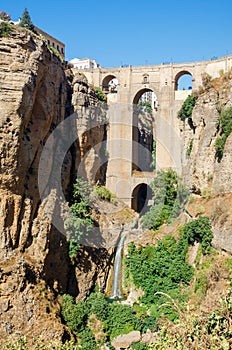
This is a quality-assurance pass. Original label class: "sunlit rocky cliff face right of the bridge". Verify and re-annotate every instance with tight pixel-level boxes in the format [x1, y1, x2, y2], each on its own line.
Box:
[182, 73, 232, 253]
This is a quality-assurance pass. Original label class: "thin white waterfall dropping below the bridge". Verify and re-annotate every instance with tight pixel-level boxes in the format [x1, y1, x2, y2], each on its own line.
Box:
[110, 235, 125, 299]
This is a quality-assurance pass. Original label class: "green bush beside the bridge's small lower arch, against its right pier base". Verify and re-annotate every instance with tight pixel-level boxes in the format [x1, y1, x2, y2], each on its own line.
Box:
[141, 169, 189, 230]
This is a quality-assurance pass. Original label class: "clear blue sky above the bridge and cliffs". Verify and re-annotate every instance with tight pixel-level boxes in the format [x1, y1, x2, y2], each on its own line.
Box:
[0, 0, 232, 67]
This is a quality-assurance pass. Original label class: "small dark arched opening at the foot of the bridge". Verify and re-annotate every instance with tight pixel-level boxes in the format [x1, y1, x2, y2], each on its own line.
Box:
[131, 183, 152, 215]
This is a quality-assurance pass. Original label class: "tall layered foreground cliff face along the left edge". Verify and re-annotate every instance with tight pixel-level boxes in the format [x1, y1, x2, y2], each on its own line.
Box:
[0, 26, 72, 339]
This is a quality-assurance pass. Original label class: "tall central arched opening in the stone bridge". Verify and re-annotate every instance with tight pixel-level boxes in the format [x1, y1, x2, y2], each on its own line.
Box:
[132, 88, 158, 171]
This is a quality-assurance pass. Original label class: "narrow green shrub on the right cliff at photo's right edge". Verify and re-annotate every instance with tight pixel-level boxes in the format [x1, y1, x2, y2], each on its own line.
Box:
[215, 107, 232, 162]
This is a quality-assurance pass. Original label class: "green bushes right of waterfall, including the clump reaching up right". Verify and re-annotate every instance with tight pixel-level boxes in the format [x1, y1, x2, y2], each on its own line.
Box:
[126, 217, 213, 320]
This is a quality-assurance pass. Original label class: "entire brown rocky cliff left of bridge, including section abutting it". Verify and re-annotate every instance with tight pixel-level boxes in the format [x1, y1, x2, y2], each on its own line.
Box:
[0, 29, 129, 341]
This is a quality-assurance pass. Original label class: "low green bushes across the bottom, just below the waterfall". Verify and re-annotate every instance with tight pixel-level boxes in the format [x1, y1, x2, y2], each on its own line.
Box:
[62, 292, 156, 344]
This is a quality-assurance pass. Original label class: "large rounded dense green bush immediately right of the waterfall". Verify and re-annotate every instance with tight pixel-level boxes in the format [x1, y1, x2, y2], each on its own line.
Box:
[126, 236, 193, 319]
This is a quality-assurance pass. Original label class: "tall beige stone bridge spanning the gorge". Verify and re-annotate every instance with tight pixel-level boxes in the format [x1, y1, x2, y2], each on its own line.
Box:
[74, 56, 232, 211]
